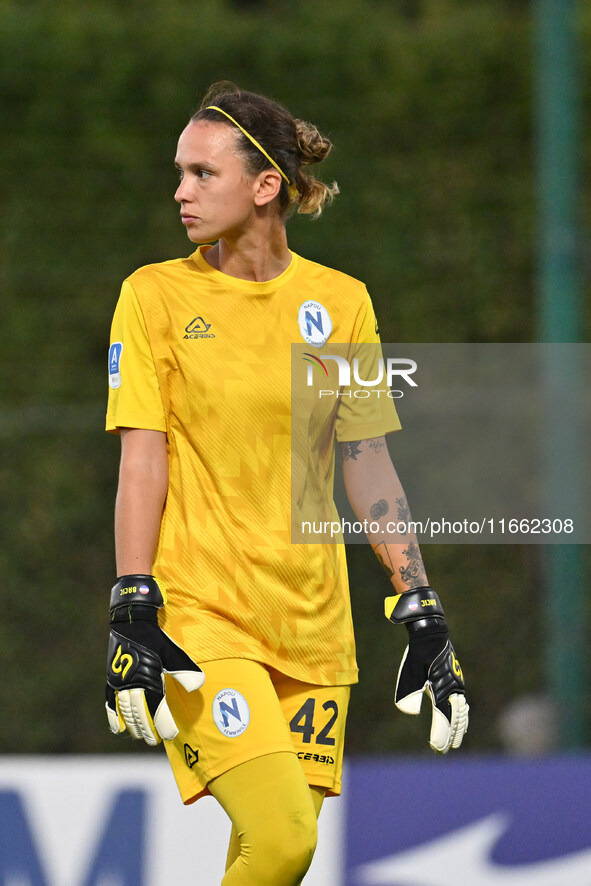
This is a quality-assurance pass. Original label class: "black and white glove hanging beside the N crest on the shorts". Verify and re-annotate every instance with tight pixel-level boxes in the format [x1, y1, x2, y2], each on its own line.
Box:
[106, 575, 205, 745]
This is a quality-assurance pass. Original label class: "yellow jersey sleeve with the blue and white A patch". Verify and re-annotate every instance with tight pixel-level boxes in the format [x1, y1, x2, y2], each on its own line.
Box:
[106, 280, 166, 433]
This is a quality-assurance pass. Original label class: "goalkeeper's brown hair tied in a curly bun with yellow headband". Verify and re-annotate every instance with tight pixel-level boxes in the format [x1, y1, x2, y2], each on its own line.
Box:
[191, 80, 339, 218]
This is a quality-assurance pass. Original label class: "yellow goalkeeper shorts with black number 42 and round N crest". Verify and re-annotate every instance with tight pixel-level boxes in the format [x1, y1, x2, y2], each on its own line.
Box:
[164, 659, 351, 803]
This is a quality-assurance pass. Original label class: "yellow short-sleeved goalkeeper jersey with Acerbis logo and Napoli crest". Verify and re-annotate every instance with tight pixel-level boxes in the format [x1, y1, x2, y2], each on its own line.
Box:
[107, 246, 399, 685]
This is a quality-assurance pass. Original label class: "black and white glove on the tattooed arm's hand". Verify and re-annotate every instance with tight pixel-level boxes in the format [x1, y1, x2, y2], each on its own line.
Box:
[385, 587, 469, 754]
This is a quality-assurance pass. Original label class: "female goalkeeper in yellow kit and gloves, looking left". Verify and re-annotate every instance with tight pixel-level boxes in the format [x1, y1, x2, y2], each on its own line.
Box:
[107, 83, 468, 886]
